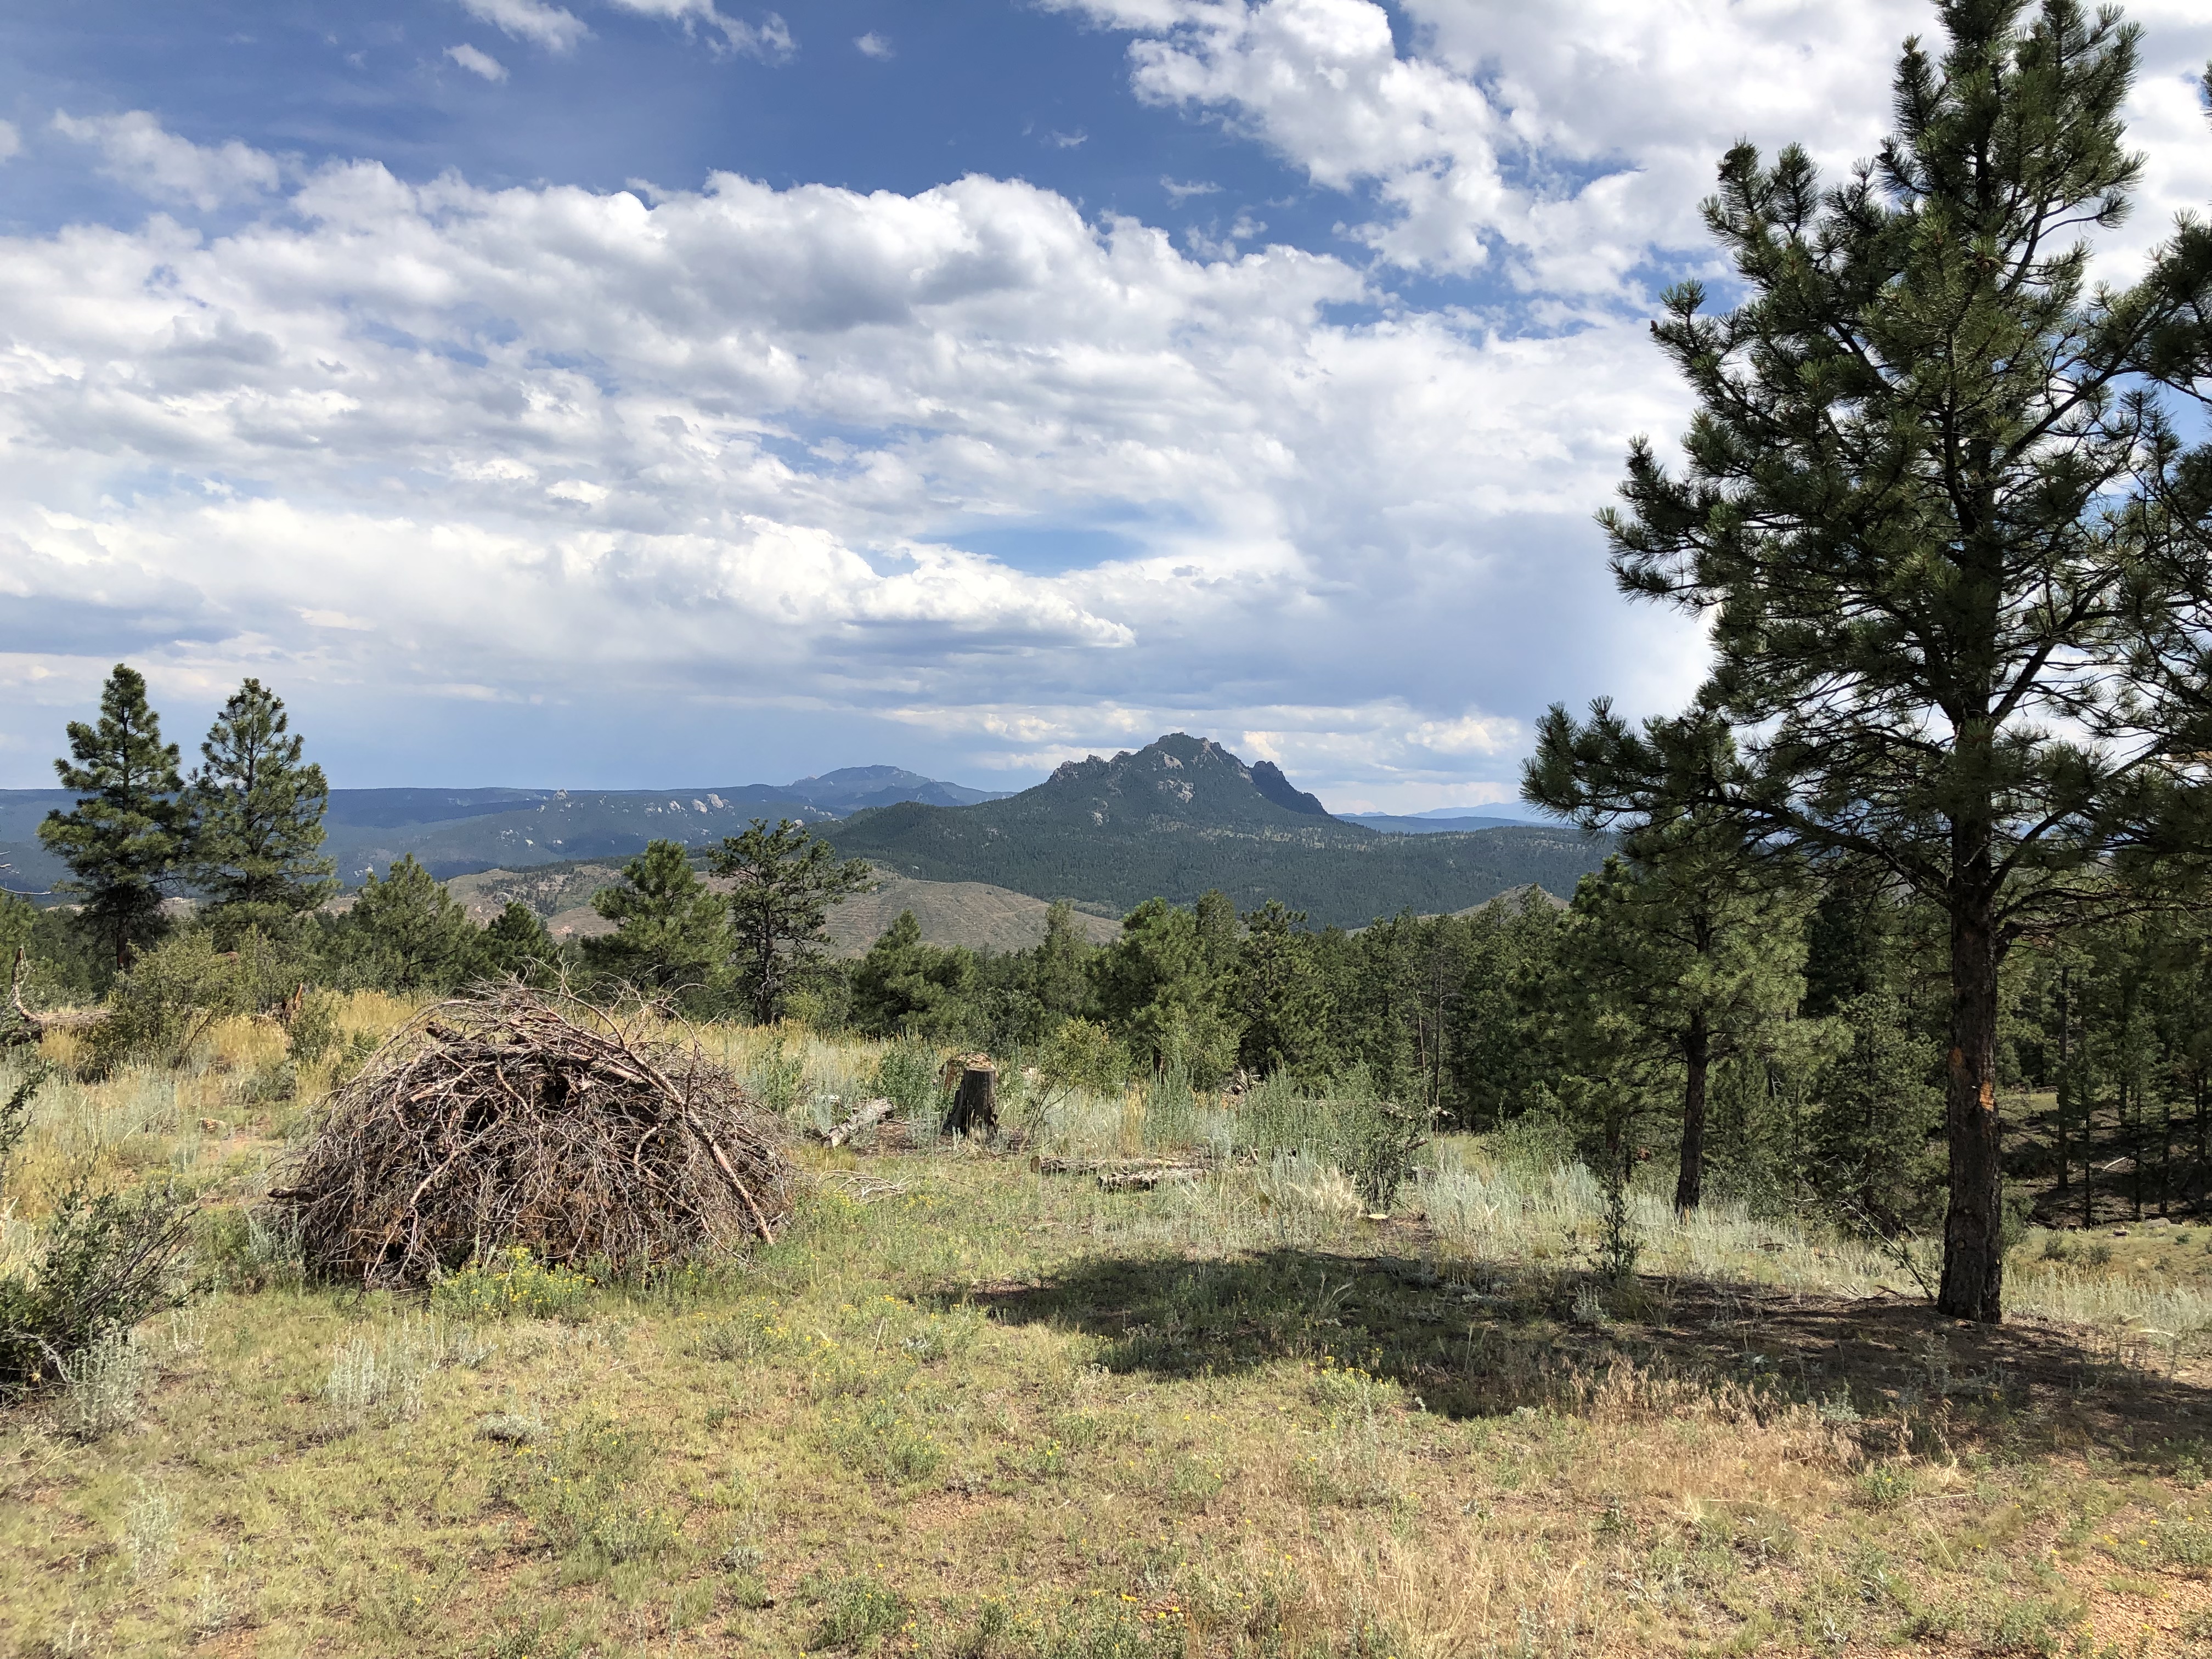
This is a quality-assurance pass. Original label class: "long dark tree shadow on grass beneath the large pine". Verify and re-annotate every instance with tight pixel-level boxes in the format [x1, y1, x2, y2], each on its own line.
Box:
[973, 1248, 2212, 1464]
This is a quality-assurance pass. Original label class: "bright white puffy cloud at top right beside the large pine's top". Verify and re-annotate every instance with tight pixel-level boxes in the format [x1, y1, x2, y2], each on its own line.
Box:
[1046, 0, 2212, 303]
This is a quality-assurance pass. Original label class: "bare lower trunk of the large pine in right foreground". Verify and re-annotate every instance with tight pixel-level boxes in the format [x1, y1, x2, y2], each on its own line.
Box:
[1936, 889, 2004, 1325]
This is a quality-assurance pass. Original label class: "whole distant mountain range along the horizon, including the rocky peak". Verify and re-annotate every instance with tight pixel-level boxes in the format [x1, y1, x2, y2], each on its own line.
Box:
[0, 732, 1606, 940]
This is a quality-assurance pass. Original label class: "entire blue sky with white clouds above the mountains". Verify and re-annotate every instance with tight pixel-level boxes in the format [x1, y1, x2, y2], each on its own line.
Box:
[0, 0, 2212, 812]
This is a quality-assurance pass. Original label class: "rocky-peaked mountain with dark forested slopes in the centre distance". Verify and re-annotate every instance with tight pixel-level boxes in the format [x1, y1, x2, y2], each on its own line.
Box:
[823, 732, 1606, 927]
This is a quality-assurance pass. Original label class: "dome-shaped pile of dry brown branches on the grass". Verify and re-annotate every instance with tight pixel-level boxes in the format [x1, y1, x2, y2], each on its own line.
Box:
[270, 984, 792, 1288]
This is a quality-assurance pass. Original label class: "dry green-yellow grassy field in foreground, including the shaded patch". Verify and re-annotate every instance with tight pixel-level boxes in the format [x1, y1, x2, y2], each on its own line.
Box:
[0, 997, 2212, 1659]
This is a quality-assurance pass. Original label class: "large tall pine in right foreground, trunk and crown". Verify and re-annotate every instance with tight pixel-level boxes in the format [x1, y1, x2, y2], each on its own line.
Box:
[1546, 0, 2212, 1321]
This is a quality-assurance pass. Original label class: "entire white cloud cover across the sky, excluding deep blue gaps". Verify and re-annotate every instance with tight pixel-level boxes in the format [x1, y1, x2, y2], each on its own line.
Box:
[0, 0, 2212, 808]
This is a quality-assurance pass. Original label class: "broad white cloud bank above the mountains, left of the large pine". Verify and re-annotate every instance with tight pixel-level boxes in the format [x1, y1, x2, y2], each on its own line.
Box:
[0, 120, 1695, 796]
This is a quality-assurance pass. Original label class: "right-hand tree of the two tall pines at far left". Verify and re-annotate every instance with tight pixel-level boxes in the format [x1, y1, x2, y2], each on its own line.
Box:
[186, 679, 336, 945]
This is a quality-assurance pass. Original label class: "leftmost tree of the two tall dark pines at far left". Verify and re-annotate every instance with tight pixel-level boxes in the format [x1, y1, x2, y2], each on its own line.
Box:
[38, 664, 186, 971]
